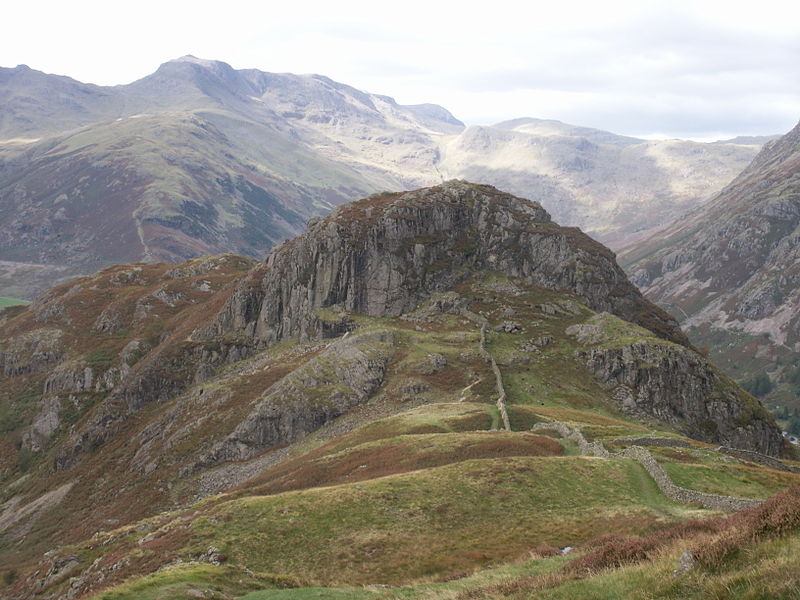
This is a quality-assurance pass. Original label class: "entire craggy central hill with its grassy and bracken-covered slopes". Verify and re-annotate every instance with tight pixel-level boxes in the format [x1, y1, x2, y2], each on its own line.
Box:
[0, 182, 796, 598]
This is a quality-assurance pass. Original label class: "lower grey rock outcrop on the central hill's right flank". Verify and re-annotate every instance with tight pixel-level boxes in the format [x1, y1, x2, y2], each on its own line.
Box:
[576, 341, 782, 456]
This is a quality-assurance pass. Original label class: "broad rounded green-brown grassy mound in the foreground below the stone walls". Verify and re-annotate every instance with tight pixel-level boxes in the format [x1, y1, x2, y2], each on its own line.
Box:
[181, 457, 686, 585]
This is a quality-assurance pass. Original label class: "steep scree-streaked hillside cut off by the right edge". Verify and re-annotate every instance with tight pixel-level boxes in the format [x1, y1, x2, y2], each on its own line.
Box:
[621, 120, 800, 414]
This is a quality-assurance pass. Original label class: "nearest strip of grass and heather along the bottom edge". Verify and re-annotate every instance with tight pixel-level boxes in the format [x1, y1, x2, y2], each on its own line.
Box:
[93, 534, 800, 600]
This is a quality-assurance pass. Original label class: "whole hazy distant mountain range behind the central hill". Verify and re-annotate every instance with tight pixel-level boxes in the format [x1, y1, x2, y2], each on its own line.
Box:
[0, 56, 759, 297]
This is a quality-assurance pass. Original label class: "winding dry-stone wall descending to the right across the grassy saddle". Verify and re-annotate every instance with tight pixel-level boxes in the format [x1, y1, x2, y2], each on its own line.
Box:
[531, 421, 762, 512]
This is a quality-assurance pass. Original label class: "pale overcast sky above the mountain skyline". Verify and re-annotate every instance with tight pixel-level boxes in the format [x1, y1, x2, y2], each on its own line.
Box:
[0, 0, 800, 139]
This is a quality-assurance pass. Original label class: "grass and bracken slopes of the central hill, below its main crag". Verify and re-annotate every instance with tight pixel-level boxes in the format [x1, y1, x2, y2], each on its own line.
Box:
[0, 264, 800, 599]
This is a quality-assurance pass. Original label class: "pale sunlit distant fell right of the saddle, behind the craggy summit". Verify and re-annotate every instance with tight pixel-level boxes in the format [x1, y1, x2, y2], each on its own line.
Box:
[439, 119, 760, 248]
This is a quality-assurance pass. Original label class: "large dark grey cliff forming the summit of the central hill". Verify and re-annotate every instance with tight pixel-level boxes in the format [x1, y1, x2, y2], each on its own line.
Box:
[203, 181, 686, 345]
